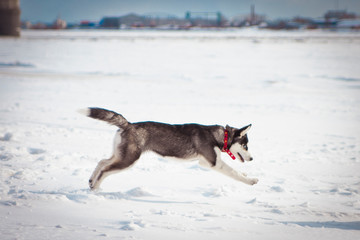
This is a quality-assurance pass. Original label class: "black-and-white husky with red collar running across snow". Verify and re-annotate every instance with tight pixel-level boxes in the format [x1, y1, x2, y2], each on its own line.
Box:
[81, 108, 258, 190]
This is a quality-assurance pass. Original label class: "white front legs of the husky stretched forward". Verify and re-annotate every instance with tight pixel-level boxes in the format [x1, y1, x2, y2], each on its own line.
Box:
[200, 148, 259, 185]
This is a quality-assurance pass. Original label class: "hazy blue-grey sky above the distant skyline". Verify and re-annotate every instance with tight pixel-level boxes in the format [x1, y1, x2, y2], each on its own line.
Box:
[20, 0, 360, 22]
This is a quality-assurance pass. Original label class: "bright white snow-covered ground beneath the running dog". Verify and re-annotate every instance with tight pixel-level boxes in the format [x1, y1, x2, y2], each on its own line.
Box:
[0, 29, 360, 240]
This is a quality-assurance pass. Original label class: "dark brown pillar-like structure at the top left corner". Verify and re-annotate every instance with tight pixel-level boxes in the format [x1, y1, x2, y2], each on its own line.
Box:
[0, 0, 21, 36]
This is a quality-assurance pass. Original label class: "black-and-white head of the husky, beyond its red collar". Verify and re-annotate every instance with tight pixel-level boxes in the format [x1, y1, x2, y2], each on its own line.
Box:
[226, 124, 253, 162]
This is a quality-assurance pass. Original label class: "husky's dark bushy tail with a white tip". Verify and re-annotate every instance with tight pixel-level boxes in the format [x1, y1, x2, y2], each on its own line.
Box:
[78, 107, 129, 129]
